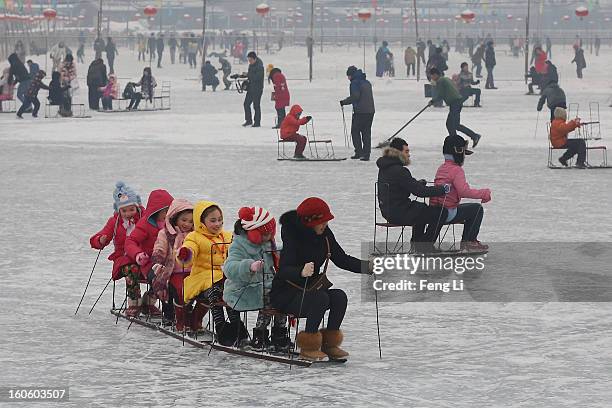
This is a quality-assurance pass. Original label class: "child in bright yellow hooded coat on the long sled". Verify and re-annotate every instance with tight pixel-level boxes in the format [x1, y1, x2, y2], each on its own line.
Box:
[177, 201, 248, 346]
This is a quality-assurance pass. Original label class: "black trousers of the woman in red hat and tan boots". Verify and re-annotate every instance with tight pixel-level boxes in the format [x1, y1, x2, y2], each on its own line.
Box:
[283, 289, 348, 333]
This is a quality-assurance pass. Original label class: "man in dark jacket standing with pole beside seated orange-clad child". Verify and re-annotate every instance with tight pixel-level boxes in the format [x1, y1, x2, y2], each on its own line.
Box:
[340, 65, 375, 161]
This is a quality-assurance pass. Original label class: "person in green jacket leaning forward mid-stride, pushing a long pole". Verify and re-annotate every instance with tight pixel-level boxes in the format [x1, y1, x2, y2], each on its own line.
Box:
[428, 68, 481, 147]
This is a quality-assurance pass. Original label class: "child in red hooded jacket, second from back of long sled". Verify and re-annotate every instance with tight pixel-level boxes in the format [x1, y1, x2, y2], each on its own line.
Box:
[121, 190, 174, 320]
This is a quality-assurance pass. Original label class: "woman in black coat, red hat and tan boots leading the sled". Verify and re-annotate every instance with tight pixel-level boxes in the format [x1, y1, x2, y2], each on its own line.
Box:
[270, 197, 369, 360]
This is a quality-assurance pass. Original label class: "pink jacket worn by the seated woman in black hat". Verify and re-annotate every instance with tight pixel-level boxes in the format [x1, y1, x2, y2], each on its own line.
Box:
[429, 159, 491, 208]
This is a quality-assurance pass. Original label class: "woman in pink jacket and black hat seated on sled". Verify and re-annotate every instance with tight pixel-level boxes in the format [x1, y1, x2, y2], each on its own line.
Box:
[430, 136, 491, 251]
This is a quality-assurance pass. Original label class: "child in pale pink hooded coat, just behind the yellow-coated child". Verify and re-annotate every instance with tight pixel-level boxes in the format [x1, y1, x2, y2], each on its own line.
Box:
[151, 198, 196, 332]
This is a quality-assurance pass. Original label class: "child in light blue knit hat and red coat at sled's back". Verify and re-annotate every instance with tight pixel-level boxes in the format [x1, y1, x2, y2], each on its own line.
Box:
[89, 181, 144, 313]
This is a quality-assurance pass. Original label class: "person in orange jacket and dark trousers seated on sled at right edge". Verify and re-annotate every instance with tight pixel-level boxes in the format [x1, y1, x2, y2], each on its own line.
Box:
[550, 107, 586, 169]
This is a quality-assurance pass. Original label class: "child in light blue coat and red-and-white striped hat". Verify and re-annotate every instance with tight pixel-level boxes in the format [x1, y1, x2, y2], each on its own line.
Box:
[223, 207, 291, 351]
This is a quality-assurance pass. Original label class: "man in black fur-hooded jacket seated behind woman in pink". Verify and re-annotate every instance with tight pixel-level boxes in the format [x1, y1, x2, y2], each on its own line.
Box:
[376, 138, 450, 252]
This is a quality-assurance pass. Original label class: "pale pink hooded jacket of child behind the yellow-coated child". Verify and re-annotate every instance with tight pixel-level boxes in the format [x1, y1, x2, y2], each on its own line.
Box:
[151, 198, 193, 282]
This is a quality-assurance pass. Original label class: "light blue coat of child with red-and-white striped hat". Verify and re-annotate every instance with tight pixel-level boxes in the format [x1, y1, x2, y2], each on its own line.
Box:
[223, 234, 276, 311]
